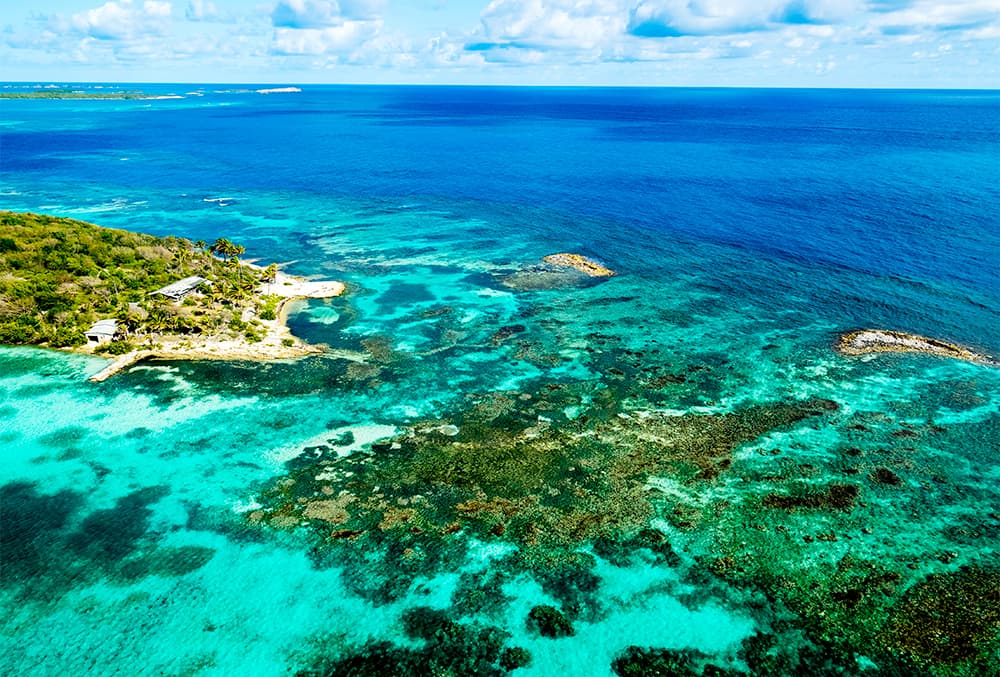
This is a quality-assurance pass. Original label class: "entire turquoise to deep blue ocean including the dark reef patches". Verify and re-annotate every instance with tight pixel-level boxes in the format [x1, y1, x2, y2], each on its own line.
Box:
[0, 85, 1000, 677]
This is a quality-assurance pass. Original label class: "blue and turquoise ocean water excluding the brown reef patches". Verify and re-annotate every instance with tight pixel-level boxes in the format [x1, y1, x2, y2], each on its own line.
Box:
[0, 85, 1000, 675]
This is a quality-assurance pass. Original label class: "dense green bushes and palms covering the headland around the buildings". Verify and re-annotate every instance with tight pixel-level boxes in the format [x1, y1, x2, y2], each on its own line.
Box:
[0, 211, 275, 352]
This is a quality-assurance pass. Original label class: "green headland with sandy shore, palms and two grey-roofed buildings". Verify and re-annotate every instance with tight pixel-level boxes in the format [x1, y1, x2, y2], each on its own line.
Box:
[0, 212, 345, 380]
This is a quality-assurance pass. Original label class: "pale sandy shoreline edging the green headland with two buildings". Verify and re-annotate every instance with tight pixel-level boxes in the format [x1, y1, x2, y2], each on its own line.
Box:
[80, 264, 347, 383]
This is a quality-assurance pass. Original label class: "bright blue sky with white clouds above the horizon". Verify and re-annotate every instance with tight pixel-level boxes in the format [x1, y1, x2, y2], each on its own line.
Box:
[0, 0, 1000, 88]
